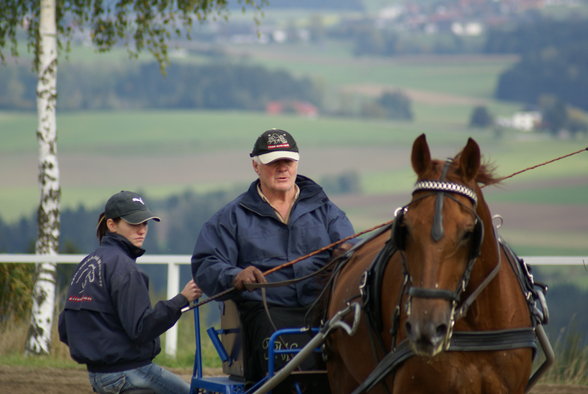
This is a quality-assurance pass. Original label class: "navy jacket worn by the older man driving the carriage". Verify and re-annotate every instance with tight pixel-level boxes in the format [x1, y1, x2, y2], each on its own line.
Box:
[192, 175, 354, 307]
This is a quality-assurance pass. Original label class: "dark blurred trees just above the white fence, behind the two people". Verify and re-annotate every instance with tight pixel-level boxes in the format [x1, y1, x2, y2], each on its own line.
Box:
[0, 172, 361, 254]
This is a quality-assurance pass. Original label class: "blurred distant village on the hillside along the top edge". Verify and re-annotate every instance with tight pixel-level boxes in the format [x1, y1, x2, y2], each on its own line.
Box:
[194, 0, 579, 44]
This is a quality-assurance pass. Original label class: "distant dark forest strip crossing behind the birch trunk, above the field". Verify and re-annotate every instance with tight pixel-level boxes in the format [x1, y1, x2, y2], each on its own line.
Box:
[0, 62, 413, 120]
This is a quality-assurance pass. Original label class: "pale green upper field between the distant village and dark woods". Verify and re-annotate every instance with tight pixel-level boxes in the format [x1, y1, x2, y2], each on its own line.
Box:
[232, 42, 516, 100]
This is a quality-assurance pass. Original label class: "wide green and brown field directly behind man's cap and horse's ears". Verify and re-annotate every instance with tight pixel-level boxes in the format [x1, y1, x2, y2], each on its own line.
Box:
[0, 107, 588, 255]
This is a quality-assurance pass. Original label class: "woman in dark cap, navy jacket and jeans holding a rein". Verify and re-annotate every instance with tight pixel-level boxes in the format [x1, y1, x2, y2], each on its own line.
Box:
[59, 191, 202, 394]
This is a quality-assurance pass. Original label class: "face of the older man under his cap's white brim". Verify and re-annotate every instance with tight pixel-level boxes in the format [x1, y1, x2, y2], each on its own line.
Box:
[253, 159, 298, 194]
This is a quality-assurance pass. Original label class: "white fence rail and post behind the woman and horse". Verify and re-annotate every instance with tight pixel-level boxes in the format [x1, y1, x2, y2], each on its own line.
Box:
[0, 254, 588, 357]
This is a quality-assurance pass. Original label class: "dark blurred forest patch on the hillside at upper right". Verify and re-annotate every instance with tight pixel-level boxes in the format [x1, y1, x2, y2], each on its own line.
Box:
[486, 19, 588, 111]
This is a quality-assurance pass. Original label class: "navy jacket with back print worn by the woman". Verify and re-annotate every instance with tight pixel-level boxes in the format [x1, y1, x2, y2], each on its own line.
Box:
[59, 233, 188, 372]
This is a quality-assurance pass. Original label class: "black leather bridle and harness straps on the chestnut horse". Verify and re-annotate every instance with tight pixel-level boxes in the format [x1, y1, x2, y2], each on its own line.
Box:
[344, 148, 576, 394]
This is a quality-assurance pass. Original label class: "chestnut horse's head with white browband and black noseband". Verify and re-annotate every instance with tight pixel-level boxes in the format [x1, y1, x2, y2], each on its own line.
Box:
[394, 134, 490, 356]
